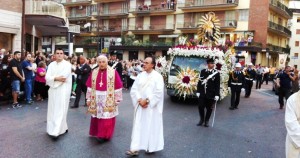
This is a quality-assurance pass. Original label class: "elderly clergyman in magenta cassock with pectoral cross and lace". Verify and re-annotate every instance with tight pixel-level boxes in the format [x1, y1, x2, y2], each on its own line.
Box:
[86, 55, 122, 143]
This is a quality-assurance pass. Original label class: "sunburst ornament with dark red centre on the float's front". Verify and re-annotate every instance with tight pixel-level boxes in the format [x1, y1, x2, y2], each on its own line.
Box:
[174, 67, 199, 99]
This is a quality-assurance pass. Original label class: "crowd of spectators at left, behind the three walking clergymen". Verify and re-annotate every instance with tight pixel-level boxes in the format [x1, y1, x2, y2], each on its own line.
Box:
[0, 49, 143, 108]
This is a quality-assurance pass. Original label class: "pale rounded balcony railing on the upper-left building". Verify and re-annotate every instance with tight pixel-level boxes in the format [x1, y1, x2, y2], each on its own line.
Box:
[25, 0, 67, 22]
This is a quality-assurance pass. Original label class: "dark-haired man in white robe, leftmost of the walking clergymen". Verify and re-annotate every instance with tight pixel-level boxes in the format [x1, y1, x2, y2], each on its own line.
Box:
[46, 49, 72, 138]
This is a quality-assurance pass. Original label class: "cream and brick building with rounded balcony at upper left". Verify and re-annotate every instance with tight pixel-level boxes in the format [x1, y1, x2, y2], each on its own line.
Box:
[0, 0, 74, 53]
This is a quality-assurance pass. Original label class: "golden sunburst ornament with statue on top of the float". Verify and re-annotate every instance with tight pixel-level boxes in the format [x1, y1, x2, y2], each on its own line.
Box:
[198, 12, 220, 45]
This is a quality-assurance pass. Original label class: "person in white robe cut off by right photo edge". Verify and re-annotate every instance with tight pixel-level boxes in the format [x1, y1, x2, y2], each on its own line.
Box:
[285, 91, 300, 158]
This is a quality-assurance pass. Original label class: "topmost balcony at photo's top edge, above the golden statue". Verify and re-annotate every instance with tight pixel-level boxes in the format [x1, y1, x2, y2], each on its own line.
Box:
[177, 0, 239, 12]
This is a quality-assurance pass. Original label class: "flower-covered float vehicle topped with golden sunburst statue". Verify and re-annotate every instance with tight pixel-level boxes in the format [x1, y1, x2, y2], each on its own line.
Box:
[156, 12, 234, 99]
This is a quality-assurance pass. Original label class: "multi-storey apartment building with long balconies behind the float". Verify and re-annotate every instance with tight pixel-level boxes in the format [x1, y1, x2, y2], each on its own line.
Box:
[62, 0, 292, 66]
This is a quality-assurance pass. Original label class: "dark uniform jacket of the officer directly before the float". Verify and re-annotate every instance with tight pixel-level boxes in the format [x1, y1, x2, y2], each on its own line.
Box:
[197, 69, 220, 99]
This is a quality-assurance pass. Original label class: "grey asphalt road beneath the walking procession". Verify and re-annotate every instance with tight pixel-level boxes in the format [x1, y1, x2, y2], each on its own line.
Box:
[0, 84, 286, 158]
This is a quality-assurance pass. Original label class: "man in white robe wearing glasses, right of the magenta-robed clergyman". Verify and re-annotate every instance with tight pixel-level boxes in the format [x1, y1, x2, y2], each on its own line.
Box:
[126, 57, 164, 156]
